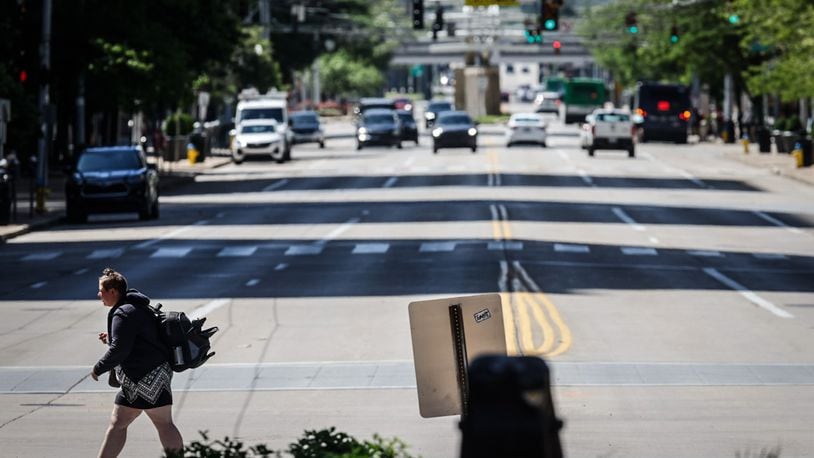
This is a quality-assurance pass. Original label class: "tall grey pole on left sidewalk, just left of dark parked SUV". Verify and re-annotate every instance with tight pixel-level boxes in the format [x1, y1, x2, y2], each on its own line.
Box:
[37, 0, 51, 213]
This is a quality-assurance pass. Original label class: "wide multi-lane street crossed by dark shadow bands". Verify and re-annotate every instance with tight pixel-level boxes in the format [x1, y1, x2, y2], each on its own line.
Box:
[0, 112, 814, 457]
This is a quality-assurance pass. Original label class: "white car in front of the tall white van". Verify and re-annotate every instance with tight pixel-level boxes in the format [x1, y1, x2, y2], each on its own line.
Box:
[232, 119, 285, 164]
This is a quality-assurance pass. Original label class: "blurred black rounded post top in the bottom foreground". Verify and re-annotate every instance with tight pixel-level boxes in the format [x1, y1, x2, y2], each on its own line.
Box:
[461, 355, 563, 458]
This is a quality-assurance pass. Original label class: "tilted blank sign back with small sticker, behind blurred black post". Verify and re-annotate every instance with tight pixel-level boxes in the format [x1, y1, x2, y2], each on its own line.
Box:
[408, 294, 506, 418]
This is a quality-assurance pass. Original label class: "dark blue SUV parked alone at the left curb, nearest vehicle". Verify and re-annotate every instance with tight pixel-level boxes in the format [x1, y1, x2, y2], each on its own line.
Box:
[65, 146, 158, 222]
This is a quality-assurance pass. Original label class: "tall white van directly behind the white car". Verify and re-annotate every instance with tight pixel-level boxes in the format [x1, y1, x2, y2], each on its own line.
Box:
[232, 88, 294, 162]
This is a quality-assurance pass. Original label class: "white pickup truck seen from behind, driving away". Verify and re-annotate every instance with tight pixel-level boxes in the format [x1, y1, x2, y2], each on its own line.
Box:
[580, 108, 636, 157]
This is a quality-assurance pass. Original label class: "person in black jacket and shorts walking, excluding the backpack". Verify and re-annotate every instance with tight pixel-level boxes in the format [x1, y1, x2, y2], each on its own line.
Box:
[90, 268, 184, 458]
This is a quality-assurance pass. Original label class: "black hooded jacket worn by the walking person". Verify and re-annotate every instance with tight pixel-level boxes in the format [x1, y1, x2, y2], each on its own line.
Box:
[93, 289, 169, 381]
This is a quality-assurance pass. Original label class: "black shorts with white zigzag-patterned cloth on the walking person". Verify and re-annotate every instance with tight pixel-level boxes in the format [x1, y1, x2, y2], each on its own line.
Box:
[116, 363, 172, 409]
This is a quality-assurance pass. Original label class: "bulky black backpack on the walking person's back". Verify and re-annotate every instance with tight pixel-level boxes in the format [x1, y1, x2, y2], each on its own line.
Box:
[150, 304, 218, 372]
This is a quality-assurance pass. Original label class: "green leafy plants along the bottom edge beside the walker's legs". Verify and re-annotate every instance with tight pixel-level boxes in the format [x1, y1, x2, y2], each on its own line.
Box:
[164, 427, 420, 458]
